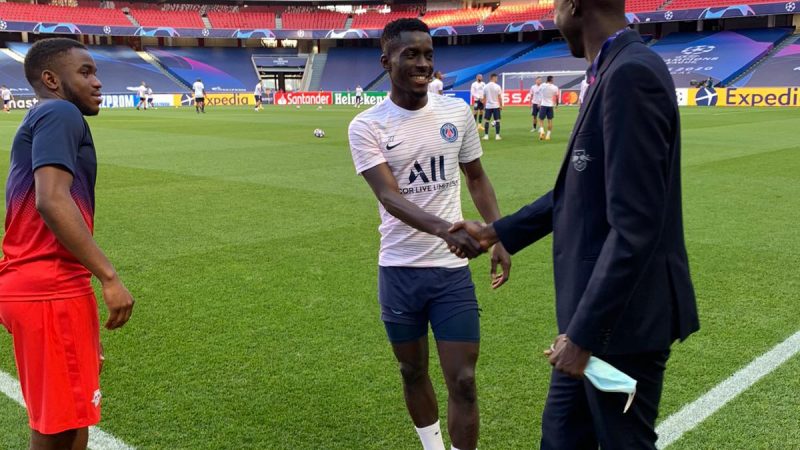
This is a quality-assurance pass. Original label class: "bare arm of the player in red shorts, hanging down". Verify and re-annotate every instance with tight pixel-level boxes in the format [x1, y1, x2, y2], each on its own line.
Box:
[33, 166, 133, 330]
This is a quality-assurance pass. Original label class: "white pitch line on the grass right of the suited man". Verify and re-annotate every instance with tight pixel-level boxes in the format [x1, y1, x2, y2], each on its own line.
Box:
[656, 331, 800, 449]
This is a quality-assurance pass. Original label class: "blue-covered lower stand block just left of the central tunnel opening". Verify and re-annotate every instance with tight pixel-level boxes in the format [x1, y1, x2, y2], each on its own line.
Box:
[145, 47, 297, 93]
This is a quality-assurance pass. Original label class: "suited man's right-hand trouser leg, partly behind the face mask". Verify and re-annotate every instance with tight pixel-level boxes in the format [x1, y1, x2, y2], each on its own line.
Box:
[585, 351, 669, 450]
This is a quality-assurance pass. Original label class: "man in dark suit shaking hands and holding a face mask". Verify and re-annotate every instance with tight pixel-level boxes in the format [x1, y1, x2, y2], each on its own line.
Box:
[453, 0, 699, 449]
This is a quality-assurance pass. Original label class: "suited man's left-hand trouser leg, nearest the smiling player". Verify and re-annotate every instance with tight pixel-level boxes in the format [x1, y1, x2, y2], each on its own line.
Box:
[541, 370, 596, 450]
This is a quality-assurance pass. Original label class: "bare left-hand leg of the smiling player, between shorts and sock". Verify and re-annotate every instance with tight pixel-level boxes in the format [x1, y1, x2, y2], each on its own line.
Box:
[387, 334, 439, 428]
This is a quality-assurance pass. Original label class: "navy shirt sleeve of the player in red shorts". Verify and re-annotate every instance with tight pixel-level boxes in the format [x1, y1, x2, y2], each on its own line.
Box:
[31, 102, 86, 175]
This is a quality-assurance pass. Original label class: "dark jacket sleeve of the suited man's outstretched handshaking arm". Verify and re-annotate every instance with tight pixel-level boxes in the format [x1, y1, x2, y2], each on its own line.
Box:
[493, 191, 553, 254]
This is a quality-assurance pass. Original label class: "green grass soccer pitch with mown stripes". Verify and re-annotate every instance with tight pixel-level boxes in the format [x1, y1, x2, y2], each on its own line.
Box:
[0, 106, 800, 449]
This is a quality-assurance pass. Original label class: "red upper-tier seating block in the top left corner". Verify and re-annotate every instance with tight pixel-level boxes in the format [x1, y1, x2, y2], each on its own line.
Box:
[0, 2, 131, 27]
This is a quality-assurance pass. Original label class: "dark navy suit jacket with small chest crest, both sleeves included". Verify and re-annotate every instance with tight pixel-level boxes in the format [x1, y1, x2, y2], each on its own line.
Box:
[494, 31, 699, 354]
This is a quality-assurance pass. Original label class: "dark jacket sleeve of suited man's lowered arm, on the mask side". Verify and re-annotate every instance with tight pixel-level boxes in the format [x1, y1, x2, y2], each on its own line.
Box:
[567, 62, 676, 353]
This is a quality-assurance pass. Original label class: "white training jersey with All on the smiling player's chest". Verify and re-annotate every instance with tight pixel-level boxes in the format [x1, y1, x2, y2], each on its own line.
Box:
[349, 95, 483, 268]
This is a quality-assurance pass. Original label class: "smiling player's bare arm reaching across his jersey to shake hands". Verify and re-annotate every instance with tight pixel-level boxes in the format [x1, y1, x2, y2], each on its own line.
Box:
[361, 163, 481, 258]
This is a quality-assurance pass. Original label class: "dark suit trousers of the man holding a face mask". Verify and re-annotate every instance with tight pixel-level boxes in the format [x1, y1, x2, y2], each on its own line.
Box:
[541, 350, 669, 450]
